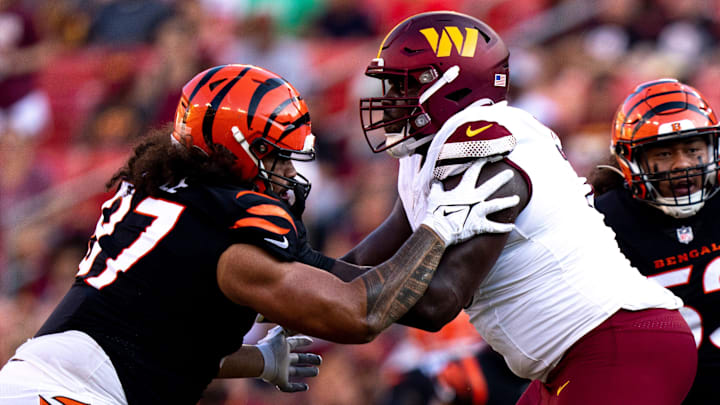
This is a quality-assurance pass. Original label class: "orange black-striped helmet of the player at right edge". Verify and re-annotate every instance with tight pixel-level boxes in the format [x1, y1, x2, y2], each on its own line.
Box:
[610, 79, 720, 217]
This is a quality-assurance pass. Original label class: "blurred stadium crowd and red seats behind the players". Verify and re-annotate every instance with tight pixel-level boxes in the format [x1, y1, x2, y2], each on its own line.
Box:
[0, 0, 720, 405]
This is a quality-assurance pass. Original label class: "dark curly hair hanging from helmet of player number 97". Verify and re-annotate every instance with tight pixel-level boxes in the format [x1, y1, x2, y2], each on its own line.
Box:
[105, 125, 247, 196]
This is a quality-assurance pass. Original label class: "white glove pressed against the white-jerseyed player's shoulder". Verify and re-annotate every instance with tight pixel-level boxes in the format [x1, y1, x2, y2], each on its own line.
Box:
[422, 160, 520, 246]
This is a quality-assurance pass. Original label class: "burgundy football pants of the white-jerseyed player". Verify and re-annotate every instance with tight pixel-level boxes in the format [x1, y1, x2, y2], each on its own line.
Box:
[517, 309, 697, 405]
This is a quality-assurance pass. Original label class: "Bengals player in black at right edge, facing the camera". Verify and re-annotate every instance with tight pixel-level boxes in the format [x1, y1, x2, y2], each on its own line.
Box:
[593, 79, 720, 405]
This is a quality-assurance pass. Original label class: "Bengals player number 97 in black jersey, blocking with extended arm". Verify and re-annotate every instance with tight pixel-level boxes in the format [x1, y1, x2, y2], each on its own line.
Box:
[0, 65, 517, 405]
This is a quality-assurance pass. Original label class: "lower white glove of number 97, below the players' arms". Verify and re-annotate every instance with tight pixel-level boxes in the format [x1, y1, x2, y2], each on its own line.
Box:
[257, 326, 322, 392]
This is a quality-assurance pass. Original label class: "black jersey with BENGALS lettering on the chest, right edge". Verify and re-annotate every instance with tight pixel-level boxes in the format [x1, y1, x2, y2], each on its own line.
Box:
[595, 189, 720, 404]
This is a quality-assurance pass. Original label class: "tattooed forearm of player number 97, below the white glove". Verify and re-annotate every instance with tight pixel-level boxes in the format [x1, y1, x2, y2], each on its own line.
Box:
[362, 225, 445, 332]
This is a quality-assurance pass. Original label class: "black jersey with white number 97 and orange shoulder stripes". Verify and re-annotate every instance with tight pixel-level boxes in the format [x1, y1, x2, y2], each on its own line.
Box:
[37, 181, 332, 405]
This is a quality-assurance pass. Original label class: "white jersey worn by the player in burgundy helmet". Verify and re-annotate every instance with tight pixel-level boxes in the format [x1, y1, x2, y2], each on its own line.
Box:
[398, 102, 682, 381]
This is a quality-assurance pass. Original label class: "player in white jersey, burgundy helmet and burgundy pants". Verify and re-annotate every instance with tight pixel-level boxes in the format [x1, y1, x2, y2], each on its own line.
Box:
[344, 12, 697, 405]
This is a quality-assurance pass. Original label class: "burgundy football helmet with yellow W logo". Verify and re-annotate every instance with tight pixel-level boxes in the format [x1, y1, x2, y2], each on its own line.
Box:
[360, 11, 509, 156]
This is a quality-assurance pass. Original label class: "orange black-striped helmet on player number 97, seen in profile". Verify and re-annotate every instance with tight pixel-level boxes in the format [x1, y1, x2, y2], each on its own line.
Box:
[172, 65, 315, 192]
